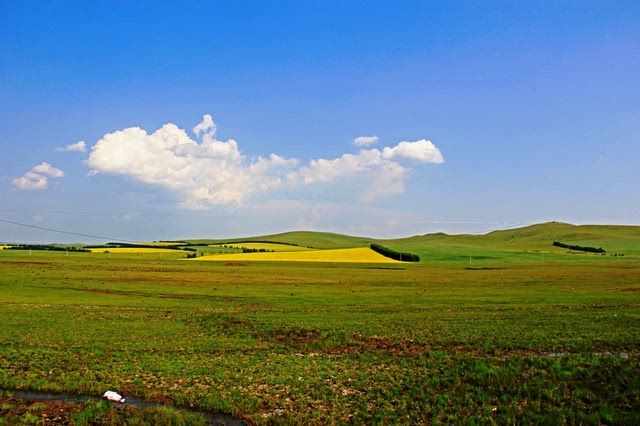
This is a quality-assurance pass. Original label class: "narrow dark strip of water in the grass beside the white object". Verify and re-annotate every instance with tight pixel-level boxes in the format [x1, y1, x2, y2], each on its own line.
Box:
[3, 389, 245, 426]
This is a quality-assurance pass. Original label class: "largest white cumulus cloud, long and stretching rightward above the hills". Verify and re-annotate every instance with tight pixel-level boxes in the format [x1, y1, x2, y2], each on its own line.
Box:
[85, 114, 442, 209]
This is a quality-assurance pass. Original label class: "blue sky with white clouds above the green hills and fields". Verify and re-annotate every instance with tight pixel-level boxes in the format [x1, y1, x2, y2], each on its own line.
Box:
[0, 1, 640, 242]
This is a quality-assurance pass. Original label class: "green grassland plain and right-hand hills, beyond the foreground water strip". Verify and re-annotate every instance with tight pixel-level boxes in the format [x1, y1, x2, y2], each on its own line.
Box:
[0, 224, 640, 424]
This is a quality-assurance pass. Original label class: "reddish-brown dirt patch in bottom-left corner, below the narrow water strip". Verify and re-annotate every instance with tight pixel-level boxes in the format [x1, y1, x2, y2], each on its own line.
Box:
[0, 397, 82, 425]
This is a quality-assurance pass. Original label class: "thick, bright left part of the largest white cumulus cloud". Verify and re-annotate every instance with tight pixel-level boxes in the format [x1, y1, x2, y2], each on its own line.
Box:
[85, 116, 297, 208]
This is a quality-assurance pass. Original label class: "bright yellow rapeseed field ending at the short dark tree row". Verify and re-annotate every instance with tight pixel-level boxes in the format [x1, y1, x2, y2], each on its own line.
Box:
[195, 247, 399, 263]
